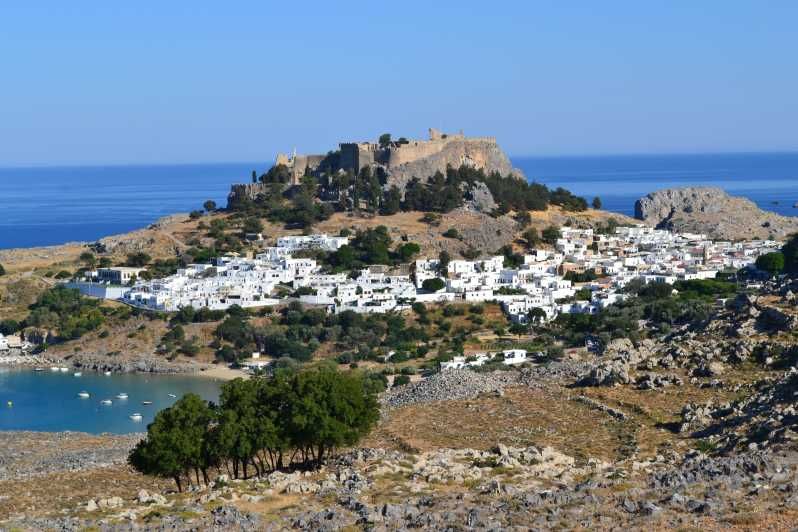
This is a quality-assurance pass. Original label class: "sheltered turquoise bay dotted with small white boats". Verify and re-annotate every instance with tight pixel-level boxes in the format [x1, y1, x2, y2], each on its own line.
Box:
[0, 368, 220, 434]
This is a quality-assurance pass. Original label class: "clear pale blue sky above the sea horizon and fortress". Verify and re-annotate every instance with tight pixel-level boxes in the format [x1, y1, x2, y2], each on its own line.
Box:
[0, 0, 798, 166]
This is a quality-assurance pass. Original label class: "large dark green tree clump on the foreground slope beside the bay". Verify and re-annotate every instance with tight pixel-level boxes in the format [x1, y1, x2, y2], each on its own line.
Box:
[129, 367, 381, 491]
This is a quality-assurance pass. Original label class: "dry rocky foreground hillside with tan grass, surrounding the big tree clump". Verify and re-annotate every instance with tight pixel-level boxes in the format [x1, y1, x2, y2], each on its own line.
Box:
[0, 280, 798, 530]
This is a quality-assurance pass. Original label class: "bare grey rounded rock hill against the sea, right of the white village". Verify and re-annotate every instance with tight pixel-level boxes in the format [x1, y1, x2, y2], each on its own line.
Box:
[635, 187, 798, 240]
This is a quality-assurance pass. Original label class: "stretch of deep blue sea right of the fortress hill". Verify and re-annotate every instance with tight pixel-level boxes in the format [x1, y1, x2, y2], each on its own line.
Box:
[513, 153, 798, 216]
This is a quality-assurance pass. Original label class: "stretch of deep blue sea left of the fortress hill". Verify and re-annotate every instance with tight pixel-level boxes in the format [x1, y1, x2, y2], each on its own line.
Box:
[0, 163, 270, 249]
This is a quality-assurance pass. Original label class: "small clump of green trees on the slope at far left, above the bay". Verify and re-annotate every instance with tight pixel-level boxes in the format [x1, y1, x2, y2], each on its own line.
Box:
[24, 286, 105, 339]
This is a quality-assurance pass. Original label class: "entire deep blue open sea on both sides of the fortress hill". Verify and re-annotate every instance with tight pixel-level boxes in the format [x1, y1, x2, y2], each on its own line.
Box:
[0, 153, 798, 249]
